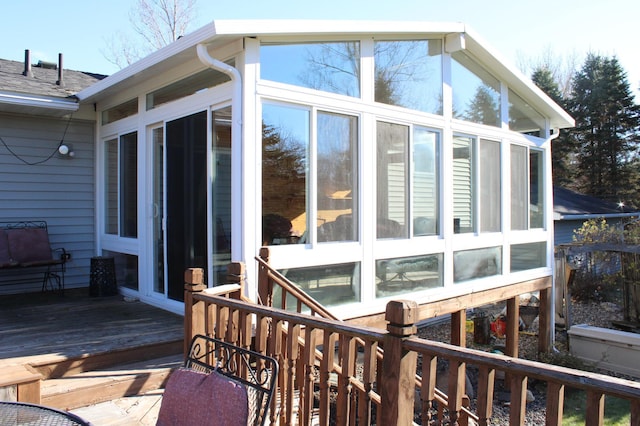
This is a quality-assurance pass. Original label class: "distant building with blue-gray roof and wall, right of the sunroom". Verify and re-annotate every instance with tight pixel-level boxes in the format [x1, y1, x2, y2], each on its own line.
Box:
[553, 187, 640, 246]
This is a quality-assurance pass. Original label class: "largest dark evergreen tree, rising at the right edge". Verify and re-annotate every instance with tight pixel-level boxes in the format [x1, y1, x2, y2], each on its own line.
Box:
[568, 54, 640, 204]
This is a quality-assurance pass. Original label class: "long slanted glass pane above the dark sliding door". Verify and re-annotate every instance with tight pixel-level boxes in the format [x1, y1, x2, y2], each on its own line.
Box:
[147, 66, 235, 111]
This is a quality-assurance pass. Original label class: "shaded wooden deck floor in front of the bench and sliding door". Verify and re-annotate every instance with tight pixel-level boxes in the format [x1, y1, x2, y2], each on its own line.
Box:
[0, 289, 184, 363]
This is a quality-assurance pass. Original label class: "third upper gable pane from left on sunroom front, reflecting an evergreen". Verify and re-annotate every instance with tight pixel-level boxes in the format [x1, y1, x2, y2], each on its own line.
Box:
[451, 52, 501, 127]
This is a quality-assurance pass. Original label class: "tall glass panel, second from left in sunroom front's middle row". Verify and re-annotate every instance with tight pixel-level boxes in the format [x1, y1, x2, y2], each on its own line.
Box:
[317, 112, 358, 242]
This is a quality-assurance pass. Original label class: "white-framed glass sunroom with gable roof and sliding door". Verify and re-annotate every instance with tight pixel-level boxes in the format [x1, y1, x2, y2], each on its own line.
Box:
[0, 21, 573, 318]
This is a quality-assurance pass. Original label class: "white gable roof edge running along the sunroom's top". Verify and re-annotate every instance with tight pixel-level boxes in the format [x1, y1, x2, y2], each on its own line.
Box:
[78, 20, 574, 128]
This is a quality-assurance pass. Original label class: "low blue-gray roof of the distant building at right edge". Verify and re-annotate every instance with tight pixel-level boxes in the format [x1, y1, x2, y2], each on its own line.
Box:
[553, 186, 639, 220]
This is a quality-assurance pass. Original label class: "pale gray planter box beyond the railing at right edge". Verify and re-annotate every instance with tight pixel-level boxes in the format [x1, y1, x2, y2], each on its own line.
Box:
[568, 324, 640, 378]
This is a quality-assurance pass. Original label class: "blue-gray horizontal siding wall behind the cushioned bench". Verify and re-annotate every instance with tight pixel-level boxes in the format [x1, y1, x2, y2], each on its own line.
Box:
[0, 113, 95, 294]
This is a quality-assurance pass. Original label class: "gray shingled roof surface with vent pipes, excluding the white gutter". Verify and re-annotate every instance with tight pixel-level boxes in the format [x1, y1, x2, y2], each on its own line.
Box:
[0, 59, 106, 98]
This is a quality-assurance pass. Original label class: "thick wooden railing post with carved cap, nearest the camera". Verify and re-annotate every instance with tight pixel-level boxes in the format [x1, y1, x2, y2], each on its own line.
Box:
[380, 300, 418, 426]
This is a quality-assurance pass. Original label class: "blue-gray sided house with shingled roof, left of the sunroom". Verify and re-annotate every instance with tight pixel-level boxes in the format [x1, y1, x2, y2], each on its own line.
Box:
[0, 51, 104, 294]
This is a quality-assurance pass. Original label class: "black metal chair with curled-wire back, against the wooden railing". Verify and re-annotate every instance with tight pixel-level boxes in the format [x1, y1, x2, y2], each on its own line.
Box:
[161, 335, 278, 426]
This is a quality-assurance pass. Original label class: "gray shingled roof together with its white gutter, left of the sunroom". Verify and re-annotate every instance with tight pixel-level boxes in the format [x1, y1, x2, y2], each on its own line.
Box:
[0, 59, 106, 115]
